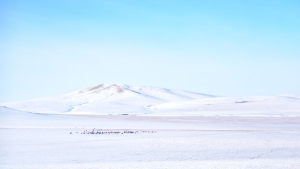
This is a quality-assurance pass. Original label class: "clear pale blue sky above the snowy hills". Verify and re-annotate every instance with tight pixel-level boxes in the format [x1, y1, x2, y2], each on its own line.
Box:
[0, 0, 300, 102]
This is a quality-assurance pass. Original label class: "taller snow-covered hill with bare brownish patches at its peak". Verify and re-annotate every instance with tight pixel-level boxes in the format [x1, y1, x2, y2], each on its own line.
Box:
[1, 84, 214, 115]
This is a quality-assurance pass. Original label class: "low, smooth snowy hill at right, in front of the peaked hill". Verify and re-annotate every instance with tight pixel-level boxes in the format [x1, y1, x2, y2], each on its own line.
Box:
[149, 95, 300, 117]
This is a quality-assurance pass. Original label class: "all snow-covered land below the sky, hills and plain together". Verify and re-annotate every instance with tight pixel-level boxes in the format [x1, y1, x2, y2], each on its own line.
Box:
[0, 85, 300, 169]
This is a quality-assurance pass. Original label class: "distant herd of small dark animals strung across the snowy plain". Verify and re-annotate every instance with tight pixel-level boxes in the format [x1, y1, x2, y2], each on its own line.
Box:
[70, 128, 156, 134]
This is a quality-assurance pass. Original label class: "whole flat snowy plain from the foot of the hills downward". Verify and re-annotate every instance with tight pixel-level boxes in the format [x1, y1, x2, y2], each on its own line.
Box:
[0, 107, 300, 169]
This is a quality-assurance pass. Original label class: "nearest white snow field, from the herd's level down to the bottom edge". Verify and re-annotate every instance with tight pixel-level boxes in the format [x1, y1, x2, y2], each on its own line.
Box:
[0, 129, 300, 169]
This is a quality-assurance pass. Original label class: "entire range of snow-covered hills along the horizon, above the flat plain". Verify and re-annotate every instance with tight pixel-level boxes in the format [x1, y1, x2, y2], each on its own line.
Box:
[1, 84, 300, 117]
